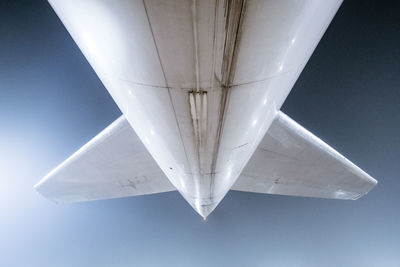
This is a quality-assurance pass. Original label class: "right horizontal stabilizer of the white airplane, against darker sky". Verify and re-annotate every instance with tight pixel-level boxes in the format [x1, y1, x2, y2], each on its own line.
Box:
[232, 112, 377, 199]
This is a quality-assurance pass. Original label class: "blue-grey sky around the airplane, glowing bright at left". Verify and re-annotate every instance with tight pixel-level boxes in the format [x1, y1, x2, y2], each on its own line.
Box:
[0, 0, 400, 267]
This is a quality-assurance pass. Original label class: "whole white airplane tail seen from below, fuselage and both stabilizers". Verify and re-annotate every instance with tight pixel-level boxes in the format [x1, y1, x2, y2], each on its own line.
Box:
[35, 0, 377, 219]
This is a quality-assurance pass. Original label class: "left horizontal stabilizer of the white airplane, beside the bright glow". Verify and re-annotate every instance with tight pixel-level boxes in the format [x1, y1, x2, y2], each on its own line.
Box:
[35, 116, 175, 203]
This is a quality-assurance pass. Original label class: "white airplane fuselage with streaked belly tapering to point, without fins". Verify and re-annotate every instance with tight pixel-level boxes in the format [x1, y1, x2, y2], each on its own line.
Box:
[50, 0, 342, 217]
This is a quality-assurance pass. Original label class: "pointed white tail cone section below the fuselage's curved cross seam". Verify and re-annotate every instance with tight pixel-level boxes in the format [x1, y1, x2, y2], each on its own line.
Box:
[97, 70, 300, 216]
